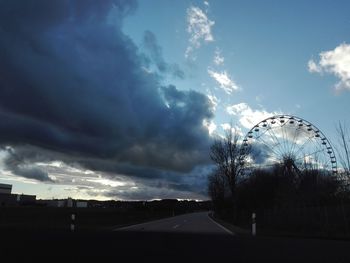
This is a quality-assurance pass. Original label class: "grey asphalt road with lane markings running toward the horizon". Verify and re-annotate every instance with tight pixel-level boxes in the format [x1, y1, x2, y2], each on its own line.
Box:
[114, 212, 233, 235]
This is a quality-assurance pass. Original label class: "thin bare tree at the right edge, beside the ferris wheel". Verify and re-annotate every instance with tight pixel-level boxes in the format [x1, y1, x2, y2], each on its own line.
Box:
[336, 122, 350, 184]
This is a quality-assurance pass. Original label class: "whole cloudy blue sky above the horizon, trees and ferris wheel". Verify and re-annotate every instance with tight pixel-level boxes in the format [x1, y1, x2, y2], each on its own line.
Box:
[0, 0, 350, 200]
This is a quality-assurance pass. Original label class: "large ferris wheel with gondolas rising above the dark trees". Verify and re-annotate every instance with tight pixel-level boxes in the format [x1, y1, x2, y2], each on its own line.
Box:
[239, 115, 337, 180]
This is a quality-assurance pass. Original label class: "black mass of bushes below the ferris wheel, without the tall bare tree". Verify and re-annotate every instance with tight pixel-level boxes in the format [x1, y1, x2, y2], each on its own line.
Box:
[213, 167, 350, 238]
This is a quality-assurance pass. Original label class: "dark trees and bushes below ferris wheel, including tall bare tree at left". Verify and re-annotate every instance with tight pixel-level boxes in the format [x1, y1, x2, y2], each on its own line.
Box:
[208, 127, 350, 238]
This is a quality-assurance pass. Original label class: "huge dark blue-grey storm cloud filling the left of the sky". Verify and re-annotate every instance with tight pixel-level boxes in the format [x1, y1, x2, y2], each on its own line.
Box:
[0, 0, 213, 186]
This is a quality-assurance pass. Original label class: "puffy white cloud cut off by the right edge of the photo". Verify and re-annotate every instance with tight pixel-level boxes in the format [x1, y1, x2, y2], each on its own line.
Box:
[308, 43, 350, 90]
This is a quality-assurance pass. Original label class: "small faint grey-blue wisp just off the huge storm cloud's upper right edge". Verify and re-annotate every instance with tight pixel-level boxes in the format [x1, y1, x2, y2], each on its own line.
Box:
[143, 31, 185, 79]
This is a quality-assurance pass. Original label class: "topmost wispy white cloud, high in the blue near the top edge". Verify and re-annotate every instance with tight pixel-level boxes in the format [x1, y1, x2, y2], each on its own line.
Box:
[185, 6, 215, 58]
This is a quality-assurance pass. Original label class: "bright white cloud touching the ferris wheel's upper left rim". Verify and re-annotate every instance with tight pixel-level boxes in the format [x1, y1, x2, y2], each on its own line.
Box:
[226, 103, 279, 129]
